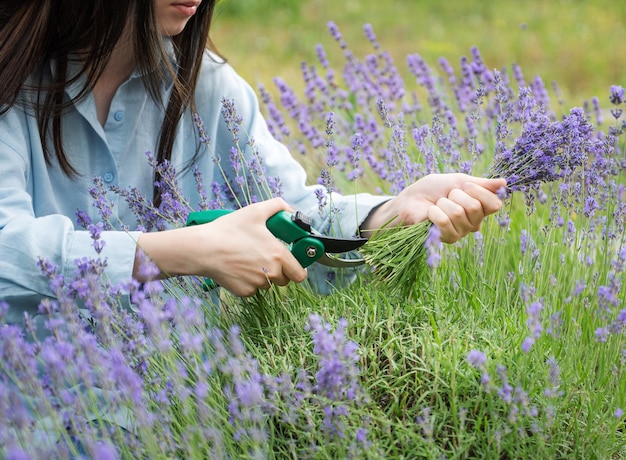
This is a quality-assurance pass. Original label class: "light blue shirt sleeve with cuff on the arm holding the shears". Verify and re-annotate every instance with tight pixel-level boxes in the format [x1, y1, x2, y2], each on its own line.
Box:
[0, 108, 138, 321]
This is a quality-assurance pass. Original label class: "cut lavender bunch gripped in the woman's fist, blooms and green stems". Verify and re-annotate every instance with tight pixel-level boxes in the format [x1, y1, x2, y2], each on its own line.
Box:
[360, 108, 594, 296]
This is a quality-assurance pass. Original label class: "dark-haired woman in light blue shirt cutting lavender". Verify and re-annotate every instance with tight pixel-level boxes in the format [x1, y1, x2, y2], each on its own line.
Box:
[0, 0, 505, 311]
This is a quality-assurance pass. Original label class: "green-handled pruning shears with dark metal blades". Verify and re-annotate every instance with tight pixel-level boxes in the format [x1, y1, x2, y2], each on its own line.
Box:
[187, 209, 367, 287]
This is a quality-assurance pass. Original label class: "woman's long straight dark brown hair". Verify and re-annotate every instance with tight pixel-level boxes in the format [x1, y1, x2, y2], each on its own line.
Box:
[0, 0, 217, 205]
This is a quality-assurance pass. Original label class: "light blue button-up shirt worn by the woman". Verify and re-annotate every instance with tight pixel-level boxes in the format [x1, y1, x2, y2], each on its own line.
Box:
[0, 53, 389, 321]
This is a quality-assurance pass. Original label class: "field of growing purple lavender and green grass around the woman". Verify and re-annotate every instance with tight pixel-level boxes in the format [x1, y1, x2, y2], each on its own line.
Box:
[0, 3, 626, 459]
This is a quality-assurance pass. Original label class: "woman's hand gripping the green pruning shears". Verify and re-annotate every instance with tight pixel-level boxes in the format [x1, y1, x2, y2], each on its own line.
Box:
[134, 198, 306, 297]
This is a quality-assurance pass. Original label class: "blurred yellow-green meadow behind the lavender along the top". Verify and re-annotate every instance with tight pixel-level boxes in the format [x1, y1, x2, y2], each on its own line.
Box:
[212, 0, 626, 105]
